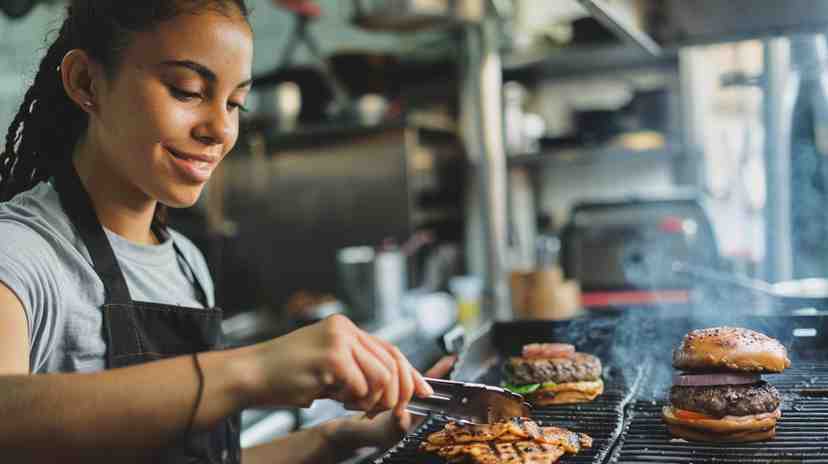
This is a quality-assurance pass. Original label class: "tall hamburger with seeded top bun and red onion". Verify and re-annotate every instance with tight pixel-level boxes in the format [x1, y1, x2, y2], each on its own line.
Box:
[662, 327, 791, 443]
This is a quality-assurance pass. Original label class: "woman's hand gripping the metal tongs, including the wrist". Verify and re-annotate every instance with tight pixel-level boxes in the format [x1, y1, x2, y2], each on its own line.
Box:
[242, 315, 432, 416]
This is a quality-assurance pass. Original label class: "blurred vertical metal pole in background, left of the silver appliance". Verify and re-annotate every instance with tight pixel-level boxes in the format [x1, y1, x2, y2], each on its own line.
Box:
[461, 11, 512, 320]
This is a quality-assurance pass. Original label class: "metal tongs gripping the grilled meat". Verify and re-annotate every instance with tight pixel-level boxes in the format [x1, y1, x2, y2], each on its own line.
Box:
[406, 378, 532, 424]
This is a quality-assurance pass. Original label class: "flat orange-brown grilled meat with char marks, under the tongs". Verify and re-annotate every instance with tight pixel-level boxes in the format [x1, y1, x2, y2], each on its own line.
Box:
[420, 418, 592, 464]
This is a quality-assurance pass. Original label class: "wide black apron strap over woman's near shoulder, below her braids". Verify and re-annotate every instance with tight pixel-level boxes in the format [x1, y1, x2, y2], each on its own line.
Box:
[55, 159, 132, 304]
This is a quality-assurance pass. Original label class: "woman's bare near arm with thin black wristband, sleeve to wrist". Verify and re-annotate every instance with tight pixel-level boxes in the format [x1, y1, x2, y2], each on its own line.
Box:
[0, 283, 249, 463]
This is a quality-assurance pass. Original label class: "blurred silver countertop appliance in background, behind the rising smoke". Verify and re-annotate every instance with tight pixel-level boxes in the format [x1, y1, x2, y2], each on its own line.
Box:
[561, 194, 719, 292]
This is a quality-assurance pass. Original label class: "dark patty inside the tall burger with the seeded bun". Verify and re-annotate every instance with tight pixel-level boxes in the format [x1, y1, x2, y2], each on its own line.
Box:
[670, 382, 781, 418]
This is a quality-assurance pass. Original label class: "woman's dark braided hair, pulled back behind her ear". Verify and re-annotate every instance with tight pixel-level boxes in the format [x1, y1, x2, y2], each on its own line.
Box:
[0, 0, 249, 223]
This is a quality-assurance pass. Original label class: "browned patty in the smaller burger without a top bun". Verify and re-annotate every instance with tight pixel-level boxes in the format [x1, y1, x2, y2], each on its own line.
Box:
[504, 353, 601, 385]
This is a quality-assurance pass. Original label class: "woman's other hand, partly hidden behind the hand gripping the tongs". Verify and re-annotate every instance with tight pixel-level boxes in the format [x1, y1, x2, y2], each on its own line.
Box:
[328, 356, 457, 449]
